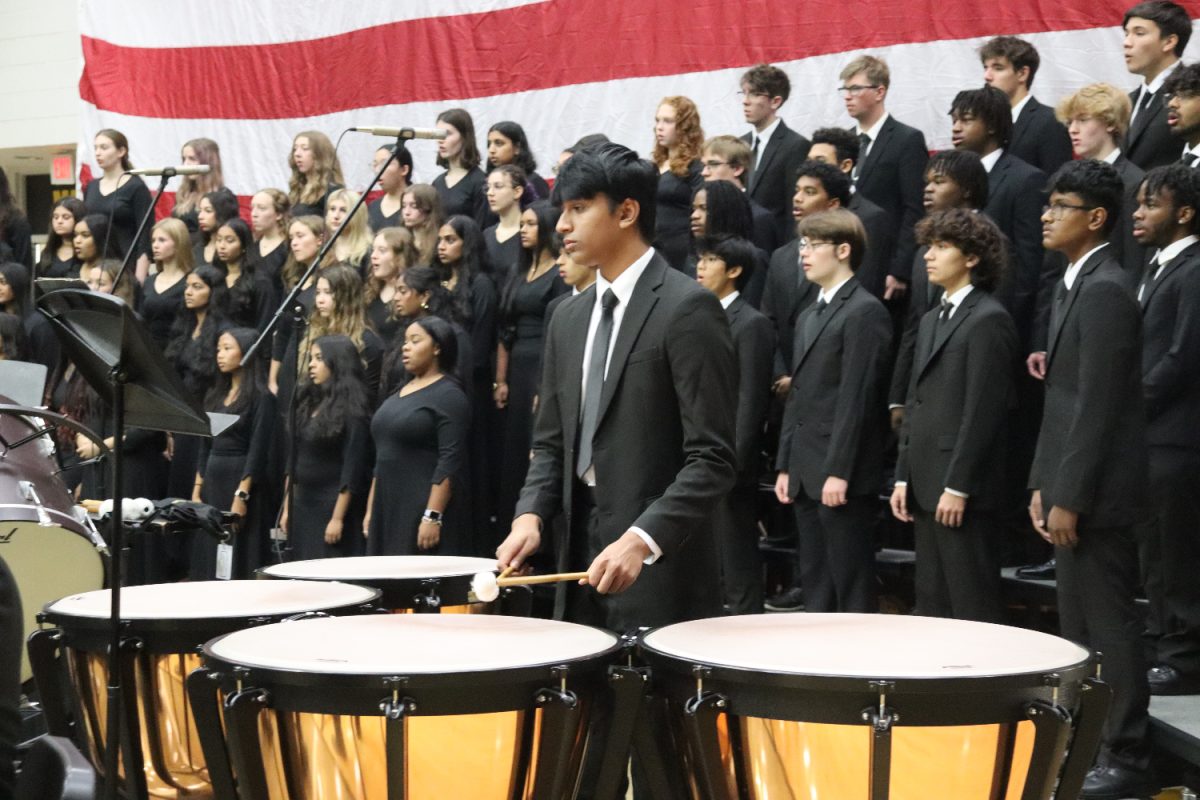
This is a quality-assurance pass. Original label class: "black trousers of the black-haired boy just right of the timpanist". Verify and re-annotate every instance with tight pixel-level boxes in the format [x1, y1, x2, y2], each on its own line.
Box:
[715, 485, 763, 614]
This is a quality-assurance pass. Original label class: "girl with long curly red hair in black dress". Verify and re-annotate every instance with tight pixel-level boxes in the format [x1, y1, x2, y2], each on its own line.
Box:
[652, 96, 704, 271]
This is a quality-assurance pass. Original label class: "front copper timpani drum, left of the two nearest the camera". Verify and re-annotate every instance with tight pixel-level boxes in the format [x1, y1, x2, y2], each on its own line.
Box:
[188, 614, 628, 800]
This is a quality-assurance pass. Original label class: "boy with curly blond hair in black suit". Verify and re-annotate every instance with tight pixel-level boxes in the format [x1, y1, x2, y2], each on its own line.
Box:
[1055, 83, 1146, 280]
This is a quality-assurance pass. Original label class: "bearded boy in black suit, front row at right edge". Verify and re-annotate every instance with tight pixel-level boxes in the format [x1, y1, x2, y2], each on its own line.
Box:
[1134, 164, 1200, 694]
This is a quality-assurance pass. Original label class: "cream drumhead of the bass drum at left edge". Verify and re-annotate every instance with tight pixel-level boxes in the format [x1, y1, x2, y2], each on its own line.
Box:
[9, 522, 104, 682]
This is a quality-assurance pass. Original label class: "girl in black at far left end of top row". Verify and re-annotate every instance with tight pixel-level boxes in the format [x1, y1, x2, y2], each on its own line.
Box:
[83, 128, 150, 283]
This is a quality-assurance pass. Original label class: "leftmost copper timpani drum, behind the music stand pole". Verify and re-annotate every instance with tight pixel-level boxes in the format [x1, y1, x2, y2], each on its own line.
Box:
[29, 581, 379, 798]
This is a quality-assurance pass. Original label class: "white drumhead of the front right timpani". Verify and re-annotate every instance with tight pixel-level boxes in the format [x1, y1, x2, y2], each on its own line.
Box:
[644, 614, 1090, 679]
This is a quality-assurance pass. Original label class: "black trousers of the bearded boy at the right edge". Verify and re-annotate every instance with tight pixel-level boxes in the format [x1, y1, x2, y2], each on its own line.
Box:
[1138, 447, 1200, 678]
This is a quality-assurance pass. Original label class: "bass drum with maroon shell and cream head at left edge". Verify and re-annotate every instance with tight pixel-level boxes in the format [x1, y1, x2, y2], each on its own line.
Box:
[0, 395, 104, 682]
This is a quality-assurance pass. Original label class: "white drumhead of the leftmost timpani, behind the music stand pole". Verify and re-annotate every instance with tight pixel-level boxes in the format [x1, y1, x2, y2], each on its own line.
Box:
[46, 581, 377, 620]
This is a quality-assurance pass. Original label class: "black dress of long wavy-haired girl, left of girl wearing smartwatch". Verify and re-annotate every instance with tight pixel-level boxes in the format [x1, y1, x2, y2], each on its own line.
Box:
[288, 417, 371, 561]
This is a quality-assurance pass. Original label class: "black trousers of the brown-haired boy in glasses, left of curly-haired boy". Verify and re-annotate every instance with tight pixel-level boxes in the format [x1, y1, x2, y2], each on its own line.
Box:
[793, 492, 878, 613]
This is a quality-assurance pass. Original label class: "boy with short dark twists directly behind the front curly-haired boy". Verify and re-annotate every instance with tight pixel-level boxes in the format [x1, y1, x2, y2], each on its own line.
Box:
[888, 150, 988, 431]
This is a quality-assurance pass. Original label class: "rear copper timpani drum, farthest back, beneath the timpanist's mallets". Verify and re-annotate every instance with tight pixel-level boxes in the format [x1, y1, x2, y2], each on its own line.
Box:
[258, 555, 530, 616]
